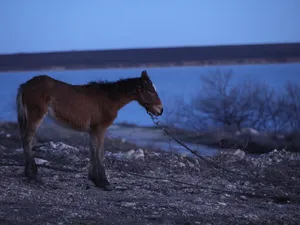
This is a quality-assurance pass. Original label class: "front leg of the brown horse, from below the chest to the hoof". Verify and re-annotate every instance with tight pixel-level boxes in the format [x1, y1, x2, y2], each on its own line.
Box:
[88, 129, 113, 191]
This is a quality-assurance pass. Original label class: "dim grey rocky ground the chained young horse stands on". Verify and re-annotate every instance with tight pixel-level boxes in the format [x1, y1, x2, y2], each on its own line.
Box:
[0, 123, 300, 225]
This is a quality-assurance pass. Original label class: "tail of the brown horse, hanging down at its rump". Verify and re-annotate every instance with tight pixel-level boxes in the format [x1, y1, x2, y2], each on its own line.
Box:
[16, 84, 27, 137]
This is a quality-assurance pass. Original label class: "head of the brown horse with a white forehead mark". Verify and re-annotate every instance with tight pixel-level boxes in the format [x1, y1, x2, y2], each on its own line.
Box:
[137, 70, 163, 116]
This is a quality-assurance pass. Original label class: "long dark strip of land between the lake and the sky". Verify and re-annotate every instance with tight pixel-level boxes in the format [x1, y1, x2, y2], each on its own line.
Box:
[0, 43, 300, 72]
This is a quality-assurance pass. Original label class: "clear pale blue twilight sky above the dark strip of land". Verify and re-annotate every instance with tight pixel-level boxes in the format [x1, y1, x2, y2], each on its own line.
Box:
[0, 0, 300, 54]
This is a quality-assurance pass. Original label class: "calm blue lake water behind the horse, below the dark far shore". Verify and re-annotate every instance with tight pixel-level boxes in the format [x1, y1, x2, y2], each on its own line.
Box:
[0, 63, 300, 126]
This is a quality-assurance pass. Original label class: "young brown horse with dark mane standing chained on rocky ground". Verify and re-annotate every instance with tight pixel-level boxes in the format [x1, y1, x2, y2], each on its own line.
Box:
[16, 71, 163, 190]
